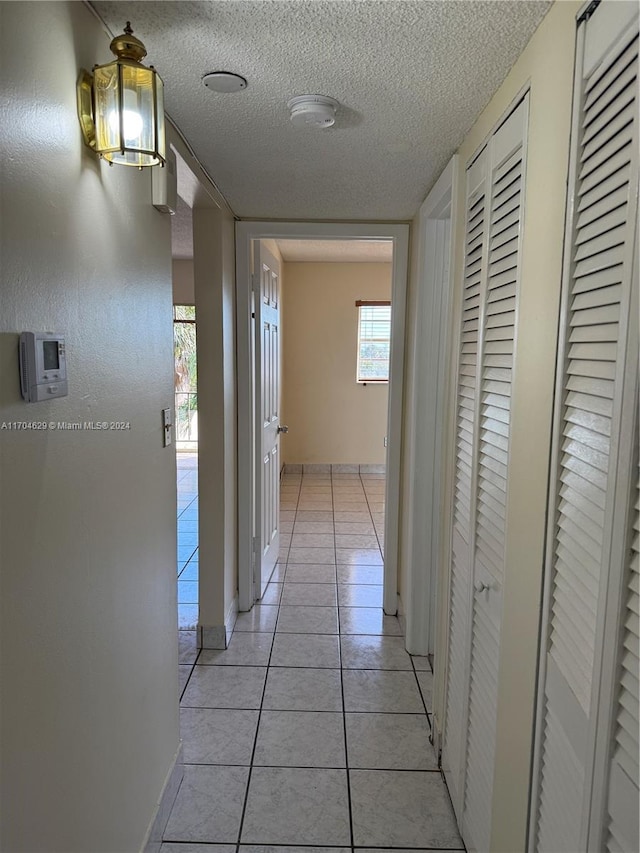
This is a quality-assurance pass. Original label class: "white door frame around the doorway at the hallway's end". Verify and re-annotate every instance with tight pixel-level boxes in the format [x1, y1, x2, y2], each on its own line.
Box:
[236, 220, 409, 615]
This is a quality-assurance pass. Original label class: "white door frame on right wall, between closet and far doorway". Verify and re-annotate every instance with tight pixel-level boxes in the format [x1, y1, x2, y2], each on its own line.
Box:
[403, 155, 459, 655]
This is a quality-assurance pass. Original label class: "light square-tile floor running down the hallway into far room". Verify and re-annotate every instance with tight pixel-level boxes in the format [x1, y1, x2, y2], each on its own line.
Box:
[168, 474, 464, 853]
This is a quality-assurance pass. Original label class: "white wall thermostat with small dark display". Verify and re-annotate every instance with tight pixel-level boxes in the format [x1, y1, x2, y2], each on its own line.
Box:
[20, 332, 67, 403]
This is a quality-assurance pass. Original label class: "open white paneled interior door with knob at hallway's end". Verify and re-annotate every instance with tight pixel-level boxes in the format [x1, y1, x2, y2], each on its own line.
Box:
[253, 240, 280, 599]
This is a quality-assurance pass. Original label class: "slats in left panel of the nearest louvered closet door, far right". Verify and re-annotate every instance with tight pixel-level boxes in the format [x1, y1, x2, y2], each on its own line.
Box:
[550, 43, 637, 713]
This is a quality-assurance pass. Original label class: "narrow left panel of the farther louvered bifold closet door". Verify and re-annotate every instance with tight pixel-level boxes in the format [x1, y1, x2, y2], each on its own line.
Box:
[442, 149, 487, 822]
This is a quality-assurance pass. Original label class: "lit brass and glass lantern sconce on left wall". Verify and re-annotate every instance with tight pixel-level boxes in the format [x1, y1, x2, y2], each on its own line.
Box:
[77, 21, 165, 169]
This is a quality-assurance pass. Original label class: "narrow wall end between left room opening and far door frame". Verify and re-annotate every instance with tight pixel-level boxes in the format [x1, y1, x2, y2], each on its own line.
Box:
[193, 207, 238, 636]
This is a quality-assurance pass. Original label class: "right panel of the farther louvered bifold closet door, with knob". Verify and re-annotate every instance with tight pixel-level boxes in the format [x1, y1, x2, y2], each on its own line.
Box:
[462, 95, 529, 851]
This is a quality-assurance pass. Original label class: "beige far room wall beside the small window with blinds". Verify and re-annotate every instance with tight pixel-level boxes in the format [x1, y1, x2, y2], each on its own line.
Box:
[281, 263, 392, 465]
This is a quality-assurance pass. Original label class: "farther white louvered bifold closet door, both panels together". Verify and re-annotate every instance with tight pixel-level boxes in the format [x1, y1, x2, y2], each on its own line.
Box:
[442, 95, 529, 850]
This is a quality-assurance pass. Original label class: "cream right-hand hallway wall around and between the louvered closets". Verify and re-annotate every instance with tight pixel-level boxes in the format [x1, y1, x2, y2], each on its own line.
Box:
[400, 1, 581, 851]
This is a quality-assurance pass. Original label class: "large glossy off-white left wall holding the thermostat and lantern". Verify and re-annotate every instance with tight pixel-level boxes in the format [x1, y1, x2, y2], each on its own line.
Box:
[0, 2, 179, 853]
